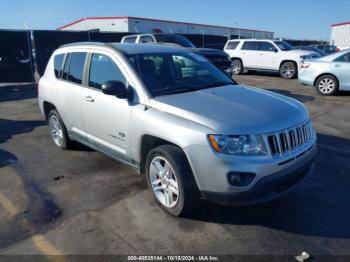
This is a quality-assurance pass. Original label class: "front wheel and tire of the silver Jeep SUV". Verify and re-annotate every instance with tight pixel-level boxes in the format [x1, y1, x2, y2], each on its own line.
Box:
[146, 145, 200, 216]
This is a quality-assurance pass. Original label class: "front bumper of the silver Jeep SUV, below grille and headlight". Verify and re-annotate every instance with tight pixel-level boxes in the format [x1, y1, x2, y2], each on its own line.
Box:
[185, 141, 317, 205]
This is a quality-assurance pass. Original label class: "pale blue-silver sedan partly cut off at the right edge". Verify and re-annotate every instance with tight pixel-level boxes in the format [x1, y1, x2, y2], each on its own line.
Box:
[298, 49, 350, 96]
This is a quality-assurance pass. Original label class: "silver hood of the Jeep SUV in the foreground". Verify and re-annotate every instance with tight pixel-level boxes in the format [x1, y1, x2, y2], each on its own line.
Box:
[150, 85, 308, 134]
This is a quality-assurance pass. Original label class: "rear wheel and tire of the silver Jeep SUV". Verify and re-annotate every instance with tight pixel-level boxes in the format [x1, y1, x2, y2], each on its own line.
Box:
[47, 110, 72, 149]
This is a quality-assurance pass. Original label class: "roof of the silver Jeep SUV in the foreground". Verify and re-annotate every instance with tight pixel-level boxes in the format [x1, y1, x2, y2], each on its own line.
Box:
[60, 42, 187, 55]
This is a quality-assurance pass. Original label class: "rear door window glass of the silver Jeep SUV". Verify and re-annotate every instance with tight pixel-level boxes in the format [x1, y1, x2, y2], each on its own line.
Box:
[62, 52, 86, 85]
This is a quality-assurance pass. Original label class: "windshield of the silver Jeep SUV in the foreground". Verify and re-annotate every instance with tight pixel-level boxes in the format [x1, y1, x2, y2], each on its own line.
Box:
[129, 53, 237, 96]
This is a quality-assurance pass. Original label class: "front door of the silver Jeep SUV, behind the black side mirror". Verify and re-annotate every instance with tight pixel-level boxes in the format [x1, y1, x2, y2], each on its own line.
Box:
[82, 51, 132, 160]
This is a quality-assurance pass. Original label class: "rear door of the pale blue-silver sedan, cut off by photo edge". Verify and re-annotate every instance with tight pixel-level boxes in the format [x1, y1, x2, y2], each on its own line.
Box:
[331, 52, 350, 90]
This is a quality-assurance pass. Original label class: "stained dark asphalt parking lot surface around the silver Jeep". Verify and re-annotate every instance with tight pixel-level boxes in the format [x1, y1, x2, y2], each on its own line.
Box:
[0, 74, 350, 256]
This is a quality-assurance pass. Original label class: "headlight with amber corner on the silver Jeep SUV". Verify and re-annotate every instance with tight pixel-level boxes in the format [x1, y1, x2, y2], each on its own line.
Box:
[208, 135, 267, 155]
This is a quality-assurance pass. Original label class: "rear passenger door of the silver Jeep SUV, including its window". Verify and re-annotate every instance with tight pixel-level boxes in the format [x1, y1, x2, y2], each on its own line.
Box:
[53, 52, 86, 132]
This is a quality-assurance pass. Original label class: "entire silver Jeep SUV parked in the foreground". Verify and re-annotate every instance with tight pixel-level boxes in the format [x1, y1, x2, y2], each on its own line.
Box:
[38, 43, 316, 216]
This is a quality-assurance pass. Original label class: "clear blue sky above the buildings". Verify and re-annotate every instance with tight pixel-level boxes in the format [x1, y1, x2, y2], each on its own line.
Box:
[0, 0, 350, 40]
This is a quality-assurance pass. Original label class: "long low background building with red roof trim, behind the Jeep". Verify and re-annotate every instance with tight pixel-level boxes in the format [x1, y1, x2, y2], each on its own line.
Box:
[58, 16, 274, 39]
